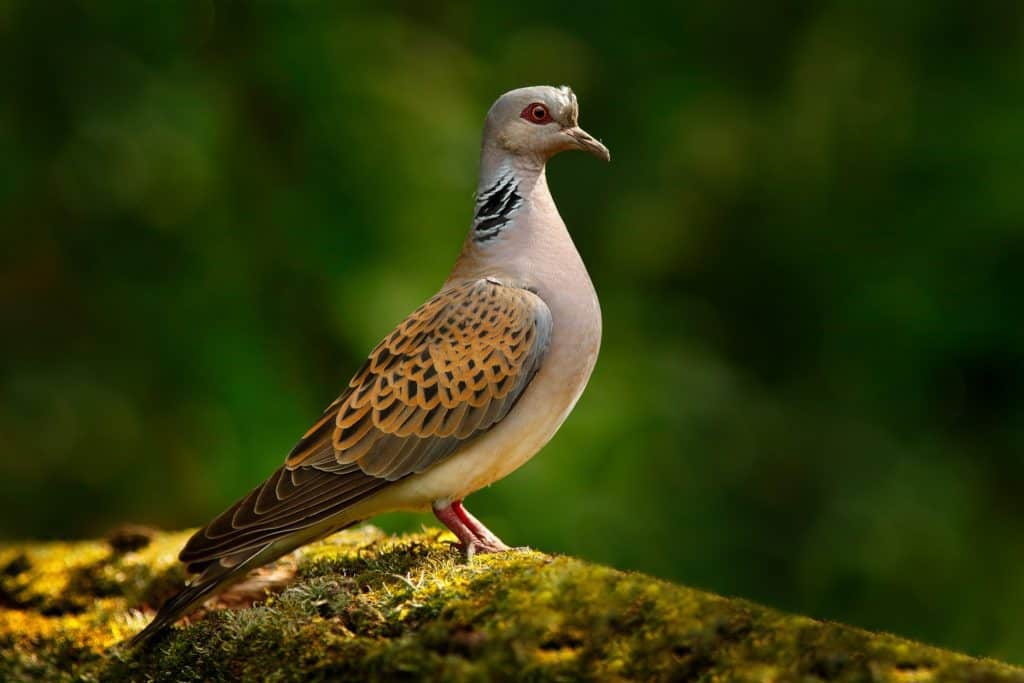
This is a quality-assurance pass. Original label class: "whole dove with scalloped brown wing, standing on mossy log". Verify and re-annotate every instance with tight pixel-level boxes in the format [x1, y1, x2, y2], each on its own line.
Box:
[129, 86, 610, 647]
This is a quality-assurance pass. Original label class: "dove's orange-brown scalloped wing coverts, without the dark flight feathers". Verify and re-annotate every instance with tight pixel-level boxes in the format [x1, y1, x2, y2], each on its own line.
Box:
[286, 280, 551, 481]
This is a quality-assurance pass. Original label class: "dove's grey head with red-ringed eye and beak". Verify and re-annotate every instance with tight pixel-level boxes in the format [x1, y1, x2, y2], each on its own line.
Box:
[483, 85, 611, 161]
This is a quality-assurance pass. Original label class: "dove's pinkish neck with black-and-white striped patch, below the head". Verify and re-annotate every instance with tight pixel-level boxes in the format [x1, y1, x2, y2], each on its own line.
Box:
[449, 148, 579, 283]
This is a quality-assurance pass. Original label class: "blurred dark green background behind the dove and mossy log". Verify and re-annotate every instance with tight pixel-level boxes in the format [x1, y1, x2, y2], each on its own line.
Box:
[0, 0, 1024, 664]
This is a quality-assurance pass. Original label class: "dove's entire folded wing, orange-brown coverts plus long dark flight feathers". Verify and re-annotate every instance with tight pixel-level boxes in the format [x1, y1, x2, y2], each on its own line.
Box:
[180, 279, 551, 570]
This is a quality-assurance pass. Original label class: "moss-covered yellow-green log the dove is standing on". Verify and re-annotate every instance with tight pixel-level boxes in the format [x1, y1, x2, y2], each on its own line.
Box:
[0, 526, 1024, 683]
